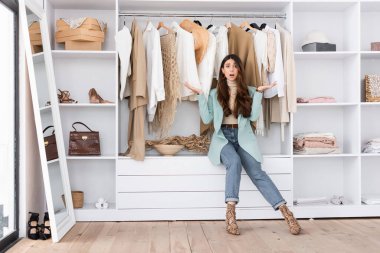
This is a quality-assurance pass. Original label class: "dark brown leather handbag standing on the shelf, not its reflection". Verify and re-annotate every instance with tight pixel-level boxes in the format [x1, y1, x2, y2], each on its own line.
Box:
[69, 122, 100, 156]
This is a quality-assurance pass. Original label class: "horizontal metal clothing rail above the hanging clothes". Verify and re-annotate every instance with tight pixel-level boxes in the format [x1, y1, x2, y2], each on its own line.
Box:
[119, 12, 286, 19]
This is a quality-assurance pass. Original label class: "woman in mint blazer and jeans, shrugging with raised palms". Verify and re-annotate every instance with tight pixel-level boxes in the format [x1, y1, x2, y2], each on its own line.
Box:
[185, 54, 301, 235]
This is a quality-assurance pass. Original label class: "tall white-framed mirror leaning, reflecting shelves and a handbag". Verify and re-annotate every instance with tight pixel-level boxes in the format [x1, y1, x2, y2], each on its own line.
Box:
[20, 0, 75, 242]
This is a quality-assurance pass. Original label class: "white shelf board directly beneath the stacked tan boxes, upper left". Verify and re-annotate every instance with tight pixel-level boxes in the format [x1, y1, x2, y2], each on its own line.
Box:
[52, 50, 117, 59]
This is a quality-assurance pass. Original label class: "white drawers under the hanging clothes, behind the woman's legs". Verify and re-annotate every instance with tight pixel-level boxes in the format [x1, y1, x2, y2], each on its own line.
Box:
[116, 156, 293, 212]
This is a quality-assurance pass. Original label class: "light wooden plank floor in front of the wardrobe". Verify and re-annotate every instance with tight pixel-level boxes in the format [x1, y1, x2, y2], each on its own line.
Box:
[7, 219, 380, 253]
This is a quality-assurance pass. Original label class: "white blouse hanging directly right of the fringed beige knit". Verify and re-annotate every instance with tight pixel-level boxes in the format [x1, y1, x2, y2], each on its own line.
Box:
[170, 21, 201, 100]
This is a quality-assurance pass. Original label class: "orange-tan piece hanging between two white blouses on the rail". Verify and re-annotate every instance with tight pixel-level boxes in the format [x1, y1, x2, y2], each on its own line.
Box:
[179, 19, 208, 64]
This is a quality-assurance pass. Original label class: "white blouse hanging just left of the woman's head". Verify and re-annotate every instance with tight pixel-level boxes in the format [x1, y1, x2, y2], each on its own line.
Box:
[198, 32, 216, 98]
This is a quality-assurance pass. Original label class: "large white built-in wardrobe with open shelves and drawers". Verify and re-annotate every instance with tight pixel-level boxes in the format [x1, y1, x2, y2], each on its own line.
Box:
[41, 0, 380, 221]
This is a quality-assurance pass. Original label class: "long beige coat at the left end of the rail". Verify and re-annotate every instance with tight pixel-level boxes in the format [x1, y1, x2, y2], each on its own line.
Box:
[127, 21, 148, 160]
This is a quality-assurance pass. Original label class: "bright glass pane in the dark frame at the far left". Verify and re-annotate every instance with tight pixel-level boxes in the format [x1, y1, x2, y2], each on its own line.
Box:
[0, 4, 15, 236]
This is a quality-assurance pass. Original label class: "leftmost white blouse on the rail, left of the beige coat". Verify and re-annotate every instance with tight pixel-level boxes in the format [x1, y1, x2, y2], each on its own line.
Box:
[115, 26, 132, 100]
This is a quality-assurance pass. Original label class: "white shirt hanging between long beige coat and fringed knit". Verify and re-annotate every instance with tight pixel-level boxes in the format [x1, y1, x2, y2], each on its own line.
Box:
[143, 22, 165, 122]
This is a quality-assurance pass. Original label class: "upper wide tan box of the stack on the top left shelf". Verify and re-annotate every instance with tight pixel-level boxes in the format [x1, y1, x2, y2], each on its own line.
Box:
[55, 28, 104, 43]
